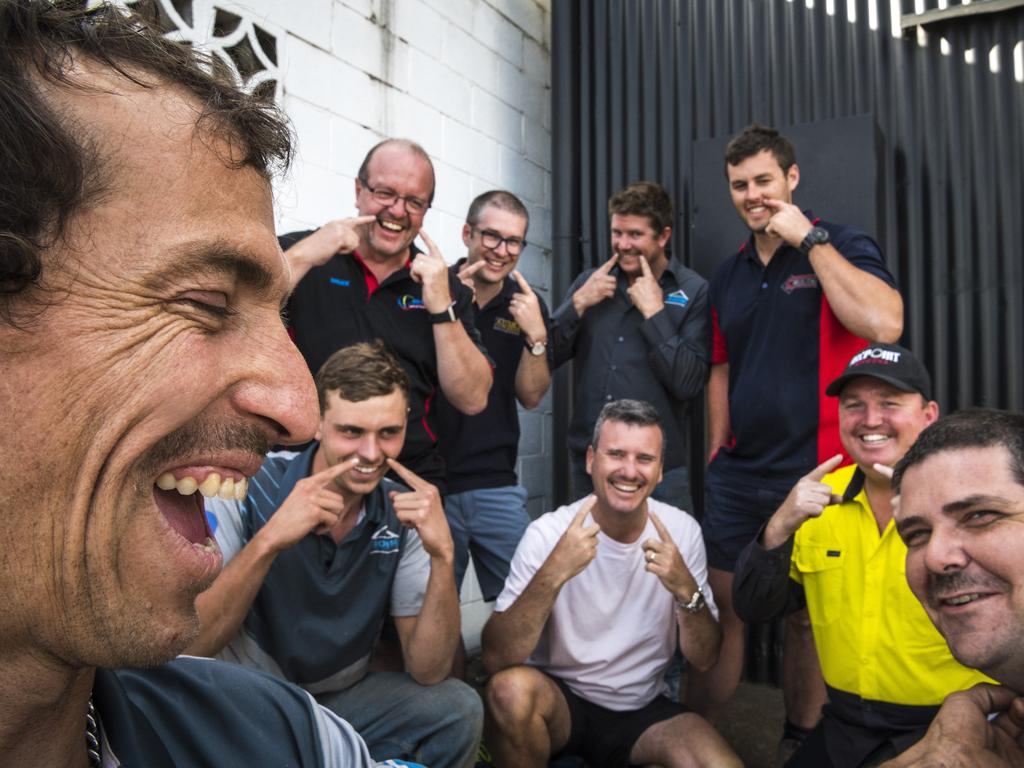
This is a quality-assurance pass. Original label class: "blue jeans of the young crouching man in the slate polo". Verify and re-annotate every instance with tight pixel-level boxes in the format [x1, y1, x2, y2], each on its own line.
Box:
[316, 672, 483, 768]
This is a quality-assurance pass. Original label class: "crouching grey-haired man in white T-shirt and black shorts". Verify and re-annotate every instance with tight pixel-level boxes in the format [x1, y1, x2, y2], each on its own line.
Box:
[482, 400, 740, 768]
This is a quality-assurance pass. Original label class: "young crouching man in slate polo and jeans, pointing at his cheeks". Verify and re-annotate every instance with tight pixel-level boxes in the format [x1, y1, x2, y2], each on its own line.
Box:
[190, 341, 482, 768]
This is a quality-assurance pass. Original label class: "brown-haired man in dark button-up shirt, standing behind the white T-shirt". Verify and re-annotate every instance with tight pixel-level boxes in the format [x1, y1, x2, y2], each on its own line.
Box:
[552, 181, 711, 510]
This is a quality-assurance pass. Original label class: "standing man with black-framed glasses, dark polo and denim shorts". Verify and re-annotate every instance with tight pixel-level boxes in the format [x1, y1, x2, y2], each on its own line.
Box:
[438, 189, 551, 672]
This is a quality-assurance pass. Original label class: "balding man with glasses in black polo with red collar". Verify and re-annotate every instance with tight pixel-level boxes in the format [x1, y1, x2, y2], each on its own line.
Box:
[280, 138, 492, 492]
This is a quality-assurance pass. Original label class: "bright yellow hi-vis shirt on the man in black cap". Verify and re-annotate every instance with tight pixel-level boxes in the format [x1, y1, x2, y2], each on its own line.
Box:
[790, 465, 991, 706]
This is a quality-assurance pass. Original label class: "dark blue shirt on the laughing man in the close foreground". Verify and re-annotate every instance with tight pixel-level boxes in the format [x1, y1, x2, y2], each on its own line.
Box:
[92, 656, 377, 768]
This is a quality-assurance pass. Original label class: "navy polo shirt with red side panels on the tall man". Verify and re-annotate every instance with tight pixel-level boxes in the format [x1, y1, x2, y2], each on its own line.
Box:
[710, 214, 896, 481]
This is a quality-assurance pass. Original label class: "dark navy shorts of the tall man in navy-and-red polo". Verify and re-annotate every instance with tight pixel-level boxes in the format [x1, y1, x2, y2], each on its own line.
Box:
[700, 471, 800, 573]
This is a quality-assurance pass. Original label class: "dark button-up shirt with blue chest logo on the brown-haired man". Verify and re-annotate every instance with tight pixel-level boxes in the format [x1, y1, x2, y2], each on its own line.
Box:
[552, 257, 711, 470]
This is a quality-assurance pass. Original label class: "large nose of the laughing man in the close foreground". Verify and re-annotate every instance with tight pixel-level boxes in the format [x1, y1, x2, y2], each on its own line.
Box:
[234, 316, 318, 444]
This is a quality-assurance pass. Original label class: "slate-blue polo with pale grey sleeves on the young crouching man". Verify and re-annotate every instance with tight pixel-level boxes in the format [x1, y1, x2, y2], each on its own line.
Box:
[206, 442, 430, 694]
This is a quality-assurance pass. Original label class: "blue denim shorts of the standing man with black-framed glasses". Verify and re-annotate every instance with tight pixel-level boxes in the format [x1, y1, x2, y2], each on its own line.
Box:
[444, 485, 529, 600]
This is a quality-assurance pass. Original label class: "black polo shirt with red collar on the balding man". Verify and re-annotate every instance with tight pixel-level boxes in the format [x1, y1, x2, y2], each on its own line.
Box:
[279, 230, 483, 490]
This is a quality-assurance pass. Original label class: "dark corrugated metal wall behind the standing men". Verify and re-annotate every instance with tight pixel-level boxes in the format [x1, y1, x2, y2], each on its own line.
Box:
[552, 0, 1024, 507]
